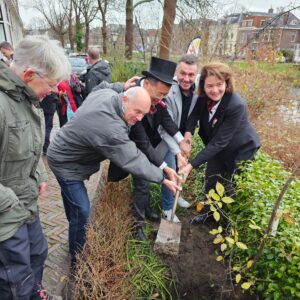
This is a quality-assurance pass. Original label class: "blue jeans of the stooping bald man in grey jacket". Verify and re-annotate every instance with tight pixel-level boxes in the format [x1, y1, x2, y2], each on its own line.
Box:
[56, 176, 90, 263]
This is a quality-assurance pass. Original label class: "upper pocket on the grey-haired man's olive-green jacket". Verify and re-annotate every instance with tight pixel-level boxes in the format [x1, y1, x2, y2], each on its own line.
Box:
[4, 121, 32, 161]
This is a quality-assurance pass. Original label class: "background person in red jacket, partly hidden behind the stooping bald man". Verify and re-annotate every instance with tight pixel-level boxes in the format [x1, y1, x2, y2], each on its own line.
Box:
[57, 80, 77, 127]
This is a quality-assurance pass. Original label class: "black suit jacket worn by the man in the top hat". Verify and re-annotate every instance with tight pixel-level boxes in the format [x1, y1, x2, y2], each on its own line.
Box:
[108, 82, 179, 181]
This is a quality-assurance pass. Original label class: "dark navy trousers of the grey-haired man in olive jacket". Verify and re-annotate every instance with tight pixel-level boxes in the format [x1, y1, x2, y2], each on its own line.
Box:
[0, 216, 48, 300]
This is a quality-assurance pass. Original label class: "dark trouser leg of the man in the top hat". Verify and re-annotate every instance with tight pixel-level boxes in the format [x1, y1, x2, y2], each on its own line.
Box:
[133, 176, 150, 225]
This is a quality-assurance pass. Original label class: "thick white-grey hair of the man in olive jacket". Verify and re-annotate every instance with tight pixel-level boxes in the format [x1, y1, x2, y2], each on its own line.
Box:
[11, 35, 71, 81]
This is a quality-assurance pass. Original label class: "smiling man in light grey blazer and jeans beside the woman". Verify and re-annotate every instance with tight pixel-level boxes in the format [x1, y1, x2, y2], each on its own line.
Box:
[160, 54, 198, 219]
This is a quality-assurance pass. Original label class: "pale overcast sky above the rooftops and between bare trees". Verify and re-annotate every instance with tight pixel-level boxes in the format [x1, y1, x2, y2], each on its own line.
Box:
[19, 0, 300, 28]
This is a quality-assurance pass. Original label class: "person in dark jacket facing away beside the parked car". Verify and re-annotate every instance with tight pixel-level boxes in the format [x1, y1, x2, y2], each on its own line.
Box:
[84, 48, 111, 97]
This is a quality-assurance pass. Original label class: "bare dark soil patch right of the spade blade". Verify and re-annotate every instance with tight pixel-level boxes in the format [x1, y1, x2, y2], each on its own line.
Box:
[152, 210, 253, 300]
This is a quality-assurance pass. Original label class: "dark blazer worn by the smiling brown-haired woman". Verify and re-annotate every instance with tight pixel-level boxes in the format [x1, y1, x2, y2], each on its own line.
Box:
[186, 93, 260, 170]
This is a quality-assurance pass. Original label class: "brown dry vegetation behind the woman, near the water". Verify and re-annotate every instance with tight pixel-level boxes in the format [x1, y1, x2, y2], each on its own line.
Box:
[234, 67, 300, 169]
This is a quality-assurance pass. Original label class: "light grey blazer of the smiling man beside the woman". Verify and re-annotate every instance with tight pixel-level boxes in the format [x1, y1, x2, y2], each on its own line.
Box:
[159, 84, 198, 155]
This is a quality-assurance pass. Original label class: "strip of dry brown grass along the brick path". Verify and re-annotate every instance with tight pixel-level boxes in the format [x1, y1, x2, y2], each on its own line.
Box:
[73, 181, 132, 300]
